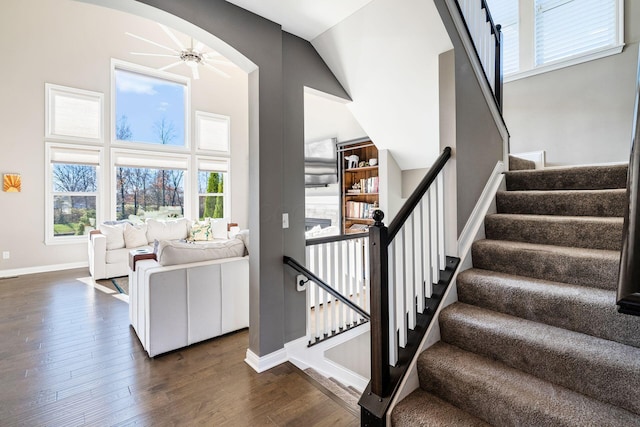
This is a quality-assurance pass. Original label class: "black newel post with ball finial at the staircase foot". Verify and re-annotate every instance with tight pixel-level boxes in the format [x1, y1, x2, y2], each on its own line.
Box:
[369, 209, 390, 397]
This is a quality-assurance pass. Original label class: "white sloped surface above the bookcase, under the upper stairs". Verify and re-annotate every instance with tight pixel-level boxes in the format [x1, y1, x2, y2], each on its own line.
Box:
[312, 0, 452, 170]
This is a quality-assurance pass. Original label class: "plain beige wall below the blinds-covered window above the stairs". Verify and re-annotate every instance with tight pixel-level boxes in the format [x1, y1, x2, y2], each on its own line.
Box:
[504, 0, 640, 166]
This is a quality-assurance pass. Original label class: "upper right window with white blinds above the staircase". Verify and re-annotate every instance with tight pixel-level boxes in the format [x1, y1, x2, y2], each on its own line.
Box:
[487, 0, 624, 81]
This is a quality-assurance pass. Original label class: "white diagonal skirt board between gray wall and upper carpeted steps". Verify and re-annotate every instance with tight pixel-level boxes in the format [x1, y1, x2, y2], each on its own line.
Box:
[458, 162, 505, 260]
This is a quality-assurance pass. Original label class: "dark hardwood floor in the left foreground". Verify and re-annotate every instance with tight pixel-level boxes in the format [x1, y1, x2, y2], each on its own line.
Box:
[0, 269, 360, 426]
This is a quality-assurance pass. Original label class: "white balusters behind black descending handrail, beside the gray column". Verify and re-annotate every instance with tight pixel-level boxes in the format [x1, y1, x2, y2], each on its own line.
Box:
[306, 234, 370, 344]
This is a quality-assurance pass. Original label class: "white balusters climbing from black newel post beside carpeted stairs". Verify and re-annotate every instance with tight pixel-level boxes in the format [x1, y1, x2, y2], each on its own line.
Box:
[388, 166, 446, 365]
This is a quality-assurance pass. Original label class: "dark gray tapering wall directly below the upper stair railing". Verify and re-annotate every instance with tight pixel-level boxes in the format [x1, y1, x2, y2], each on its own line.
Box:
[434, 0, 504, 235]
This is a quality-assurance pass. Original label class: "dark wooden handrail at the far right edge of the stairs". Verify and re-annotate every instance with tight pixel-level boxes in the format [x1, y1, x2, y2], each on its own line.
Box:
[617, 45, 640, 316]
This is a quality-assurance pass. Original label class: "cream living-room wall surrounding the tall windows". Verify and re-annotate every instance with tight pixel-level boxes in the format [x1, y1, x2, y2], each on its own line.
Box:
[0, 0, 249, 276]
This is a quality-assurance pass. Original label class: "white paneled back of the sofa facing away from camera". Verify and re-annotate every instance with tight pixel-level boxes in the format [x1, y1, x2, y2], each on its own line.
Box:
[129, 256, 249, 357]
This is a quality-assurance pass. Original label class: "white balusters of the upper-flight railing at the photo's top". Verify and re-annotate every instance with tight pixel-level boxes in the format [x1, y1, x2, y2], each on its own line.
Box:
[455, 0, 503, 110]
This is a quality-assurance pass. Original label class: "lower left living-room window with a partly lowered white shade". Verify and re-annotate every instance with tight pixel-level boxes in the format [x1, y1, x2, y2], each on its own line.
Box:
[46, 144, 101, 243]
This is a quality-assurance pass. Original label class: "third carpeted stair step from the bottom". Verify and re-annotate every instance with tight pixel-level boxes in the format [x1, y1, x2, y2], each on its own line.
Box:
[440, 303, 640, 414]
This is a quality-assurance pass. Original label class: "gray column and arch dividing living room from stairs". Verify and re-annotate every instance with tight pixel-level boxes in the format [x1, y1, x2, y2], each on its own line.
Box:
[134, 0, 348, 356]
